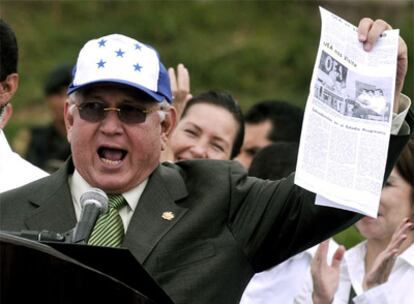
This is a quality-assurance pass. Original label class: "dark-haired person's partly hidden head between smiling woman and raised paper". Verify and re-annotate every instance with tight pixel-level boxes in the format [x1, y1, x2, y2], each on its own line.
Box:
[235, 100, 303, 169]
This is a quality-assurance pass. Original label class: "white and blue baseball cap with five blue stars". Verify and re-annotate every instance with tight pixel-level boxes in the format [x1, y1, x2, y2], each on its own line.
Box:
[68, 34, 172, 103]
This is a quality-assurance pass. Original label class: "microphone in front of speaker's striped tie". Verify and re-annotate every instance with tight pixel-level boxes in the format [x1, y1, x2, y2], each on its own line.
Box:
[72, 188, 108, 244]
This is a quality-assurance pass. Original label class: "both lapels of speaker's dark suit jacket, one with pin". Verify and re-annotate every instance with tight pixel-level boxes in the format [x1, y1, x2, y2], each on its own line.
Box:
[25, 160, 188, 263]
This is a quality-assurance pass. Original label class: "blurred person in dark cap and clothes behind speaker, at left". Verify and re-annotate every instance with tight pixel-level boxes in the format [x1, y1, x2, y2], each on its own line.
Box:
[24, 64, 72, 173]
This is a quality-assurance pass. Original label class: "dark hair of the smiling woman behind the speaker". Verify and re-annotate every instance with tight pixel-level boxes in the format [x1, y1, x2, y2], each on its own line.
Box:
[181, 90, 244, 159]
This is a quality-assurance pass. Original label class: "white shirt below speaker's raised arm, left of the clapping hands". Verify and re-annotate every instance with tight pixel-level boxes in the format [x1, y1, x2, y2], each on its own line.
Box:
[240, 240, 338, 304]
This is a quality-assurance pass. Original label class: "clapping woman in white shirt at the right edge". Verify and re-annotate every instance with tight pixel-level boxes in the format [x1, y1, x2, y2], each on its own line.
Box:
[297, 138, 414, 304]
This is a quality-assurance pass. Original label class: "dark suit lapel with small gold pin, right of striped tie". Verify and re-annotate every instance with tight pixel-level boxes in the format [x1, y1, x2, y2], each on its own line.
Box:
[124, 165, 187, 263]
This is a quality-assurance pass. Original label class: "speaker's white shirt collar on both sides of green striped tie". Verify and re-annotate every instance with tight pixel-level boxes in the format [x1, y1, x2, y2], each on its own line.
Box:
[69, 169, 148, 231]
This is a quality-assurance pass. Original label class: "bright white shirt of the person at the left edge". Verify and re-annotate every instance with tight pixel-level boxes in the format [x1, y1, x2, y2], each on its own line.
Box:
[0, 129, 48, 192]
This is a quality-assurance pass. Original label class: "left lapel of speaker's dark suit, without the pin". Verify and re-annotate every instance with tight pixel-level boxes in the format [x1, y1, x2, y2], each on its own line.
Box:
[25, 160, 76, 232]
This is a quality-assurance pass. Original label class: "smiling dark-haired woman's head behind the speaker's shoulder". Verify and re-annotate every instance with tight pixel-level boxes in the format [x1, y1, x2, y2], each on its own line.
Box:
[163, 90, 244, 161]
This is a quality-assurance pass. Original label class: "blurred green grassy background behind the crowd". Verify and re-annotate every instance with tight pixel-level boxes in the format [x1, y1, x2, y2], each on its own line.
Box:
[0, 0, 414, 245]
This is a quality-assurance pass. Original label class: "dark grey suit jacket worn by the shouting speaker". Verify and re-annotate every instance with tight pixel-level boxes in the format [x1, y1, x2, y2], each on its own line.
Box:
[0, 113, 407, 304]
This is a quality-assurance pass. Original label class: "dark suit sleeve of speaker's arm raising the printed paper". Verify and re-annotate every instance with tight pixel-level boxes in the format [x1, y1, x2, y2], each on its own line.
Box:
[228, 108, 414, 272]
